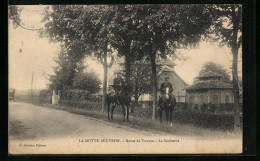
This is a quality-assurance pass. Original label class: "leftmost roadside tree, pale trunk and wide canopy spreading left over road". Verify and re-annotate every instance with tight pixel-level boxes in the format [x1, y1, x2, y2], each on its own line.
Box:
[41, 5, 115, 110]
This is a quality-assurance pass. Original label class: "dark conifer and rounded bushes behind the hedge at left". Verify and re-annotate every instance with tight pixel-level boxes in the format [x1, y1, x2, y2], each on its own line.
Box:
[49, 48, 101, 94]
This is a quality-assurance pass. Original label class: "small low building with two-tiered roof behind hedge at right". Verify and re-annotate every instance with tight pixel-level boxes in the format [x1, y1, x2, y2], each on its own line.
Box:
[186, 71, 234, 104]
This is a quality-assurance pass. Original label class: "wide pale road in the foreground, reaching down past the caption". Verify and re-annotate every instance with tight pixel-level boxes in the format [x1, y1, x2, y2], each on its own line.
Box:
[9, 102, 242, 154]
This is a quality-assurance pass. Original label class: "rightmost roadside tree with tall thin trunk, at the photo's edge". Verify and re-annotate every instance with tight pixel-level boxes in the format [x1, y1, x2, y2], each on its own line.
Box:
[210, 4, 242, 130]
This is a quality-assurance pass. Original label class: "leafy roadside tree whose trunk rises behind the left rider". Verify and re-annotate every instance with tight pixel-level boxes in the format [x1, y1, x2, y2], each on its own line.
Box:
[108, 5, 142, 87]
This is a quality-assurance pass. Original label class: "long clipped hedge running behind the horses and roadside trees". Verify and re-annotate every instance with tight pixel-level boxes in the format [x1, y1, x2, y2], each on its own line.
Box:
[57, 100, 242, 130]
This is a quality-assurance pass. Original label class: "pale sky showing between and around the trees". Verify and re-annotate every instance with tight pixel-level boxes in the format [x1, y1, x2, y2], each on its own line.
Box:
[8, 6, 242, 90]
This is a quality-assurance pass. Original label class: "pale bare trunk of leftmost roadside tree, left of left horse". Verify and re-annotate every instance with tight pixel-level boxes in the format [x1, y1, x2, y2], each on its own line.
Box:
[102, 43, 108, 112]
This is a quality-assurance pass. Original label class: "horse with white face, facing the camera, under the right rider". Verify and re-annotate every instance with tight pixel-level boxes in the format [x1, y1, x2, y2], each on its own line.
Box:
[158, 87, 176, 126]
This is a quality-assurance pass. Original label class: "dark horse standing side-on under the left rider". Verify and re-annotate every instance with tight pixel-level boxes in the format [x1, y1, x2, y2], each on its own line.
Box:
[107, 87, 133, 121]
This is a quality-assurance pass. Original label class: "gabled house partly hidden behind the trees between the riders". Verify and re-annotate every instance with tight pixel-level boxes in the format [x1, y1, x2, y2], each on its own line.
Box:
[108, 56, 188, 102]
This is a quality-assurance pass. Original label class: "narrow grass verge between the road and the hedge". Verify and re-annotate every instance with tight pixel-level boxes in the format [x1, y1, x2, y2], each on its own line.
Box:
[37, 104, 242, 139]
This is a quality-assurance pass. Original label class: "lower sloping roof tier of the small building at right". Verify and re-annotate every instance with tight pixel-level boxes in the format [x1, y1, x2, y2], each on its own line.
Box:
[186, 81, 233, 90]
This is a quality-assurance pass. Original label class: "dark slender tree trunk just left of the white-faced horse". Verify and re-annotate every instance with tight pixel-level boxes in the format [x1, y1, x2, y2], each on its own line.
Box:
[150, 51, 157, 120]
